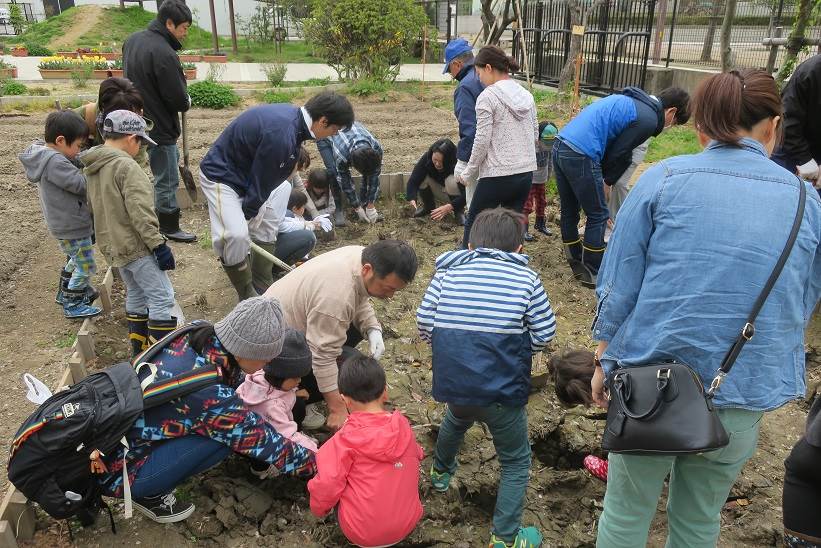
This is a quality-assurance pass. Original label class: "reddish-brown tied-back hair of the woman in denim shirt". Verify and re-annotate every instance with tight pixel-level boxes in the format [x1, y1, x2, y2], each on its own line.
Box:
[692, 69, 783, 145]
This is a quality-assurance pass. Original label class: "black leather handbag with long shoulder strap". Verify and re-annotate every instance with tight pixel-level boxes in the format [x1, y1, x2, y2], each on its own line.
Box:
[602, 181, 807, 455]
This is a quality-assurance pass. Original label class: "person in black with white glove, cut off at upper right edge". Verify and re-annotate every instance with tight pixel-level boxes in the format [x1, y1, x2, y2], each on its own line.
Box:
[772, 54, 821, 191]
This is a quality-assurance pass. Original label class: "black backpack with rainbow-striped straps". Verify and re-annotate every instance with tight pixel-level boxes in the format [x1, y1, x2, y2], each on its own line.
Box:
[8, 321, 222, 529]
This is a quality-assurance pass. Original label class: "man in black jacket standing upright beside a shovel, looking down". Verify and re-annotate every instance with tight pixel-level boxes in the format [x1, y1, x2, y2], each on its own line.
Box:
[123, 0, 197, 242]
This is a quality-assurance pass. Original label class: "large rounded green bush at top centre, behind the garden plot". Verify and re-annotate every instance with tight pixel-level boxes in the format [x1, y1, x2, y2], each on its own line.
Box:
[304, 0, 427, 81]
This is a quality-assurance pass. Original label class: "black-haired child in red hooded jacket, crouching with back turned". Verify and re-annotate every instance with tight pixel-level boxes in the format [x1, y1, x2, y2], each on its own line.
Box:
[308, 355, 424, 547]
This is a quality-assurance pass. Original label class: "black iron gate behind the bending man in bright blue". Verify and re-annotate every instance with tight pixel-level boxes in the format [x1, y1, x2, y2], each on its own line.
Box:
[513, 0, 656, 94]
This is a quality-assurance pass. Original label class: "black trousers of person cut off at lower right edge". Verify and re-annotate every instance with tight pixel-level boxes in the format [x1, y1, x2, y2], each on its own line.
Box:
[783, 438, 821, 545]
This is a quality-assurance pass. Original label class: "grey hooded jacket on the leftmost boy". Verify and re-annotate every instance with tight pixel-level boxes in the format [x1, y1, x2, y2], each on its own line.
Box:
[18, 140, 94, 240]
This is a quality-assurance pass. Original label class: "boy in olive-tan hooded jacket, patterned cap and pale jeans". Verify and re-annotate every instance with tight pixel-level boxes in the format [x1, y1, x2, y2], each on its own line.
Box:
[81, 110, 177, 355]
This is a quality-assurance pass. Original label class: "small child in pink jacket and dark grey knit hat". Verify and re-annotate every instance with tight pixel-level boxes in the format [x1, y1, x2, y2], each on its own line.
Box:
[237, 329, 317, 464]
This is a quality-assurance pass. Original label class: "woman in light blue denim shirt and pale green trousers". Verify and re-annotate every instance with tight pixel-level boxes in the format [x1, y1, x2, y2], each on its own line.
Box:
[592, 71, 821, 548]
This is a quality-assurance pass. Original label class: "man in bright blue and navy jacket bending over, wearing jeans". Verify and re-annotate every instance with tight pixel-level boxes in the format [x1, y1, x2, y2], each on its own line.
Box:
[553, 87, 690, 288]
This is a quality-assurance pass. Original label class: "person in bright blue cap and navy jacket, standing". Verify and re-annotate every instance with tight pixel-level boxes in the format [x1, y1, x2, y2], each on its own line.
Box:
[446, 38, 485, 211]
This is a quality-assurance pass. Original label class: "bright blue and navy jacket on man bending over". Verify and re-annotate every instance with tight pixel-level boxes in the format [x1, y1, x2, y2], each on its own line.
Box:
[558, 87, 664, 185]
